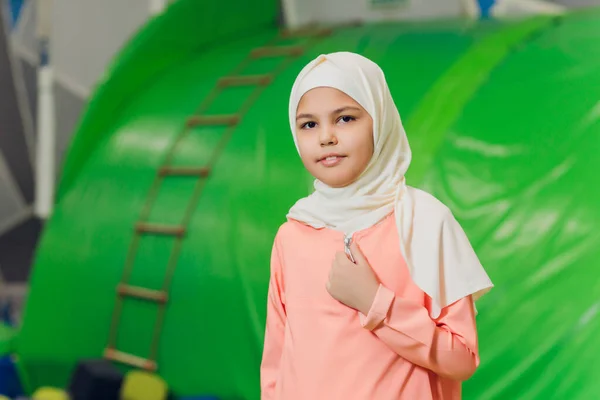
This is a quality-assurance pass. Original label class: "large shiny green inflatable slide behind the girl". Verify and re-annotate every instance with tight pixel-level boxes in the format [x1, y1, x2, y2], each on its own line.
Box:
[15, 0, 600, 400]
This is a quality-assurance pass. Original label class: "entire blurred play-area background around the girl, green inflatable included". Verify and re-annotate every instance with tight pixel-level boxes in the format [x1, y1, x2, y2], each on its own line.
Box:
[0, 0, 600, 400]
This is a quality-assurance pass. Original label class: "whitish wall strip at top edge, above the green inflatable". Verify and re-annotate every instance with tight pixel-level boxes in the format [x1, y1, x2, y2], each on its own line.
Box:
[283, 0, 474, 27]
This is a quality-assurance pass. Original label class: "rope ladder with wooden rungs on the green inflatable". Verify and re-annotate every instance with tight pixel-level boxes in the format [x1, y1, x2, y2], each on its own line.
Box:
[104, 25, 331, 371]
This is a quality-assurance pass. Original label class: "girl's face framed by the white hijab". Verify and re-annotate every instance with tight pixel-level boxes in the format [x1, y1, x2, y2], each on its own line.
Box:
[296, 87, 373, 188]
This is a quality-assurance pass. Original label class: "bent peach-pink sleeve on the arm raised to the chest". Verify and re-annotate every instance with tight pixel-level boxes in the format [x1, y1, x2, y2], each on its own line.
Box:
[360, 285, 479, 381]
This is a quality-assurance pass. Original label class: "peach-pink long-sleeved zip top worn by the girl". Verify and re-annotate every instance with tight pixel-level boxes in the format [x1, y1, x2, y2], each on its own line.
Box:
[261, 211, 479, 400]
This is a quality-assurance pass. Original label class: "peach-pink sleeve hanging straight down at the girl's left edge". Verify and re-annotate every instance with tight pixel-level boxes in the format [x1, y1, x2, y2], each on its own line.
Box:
[260, 239, 286, 400]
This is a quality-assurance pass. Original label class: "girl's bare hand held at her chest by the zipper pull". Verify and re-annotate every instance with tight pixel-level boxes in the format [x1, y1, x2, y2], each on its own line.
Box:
[327, 242, 379, 315]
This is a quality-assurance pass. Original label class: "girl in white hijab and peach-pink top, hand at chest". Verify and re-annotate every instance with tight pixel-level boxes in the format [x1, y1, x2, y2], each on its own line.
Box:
[261, 52, 492, 400]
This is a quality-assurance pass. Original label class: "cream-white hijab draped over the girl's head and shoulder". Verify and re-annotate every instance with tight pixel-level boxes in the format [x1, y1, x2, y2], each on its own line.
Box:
[288, 52, 493, 318]
